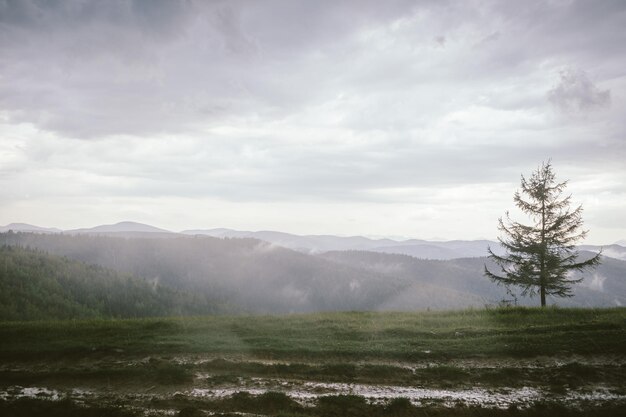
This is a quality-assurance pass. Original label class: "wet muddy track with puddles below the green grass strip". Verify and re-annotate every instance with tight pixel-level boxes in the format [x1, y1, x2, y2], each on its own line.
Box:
[0, 352, 626, 416]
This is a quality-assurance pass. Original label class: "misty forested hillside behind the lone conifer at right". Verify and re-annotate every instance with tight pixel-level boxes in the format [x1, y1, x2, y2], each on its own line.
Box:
[323, 251, 626, 310]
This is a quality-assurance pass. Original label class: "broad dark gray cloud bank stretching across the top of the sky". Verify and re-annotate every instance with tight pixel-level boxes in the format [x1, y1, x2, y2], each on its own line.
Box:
[0, 0, 623, 138]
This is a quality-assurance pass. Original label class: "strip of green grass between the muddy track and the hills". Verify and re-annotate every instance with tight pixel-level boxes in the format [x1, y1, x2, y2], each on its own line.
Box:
[0, 308, 626, 361]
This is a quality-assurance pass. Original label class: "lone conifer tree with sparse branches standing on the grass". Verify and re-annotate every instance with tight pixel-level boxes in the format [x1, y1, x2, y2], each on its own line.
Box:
[485, 161, 600, 307]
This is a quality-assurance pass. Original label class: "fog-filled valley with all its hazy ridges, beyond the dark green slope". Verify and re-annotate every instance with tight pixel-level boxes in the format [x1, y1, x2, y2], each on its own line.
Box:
[0, 222, 626, 315]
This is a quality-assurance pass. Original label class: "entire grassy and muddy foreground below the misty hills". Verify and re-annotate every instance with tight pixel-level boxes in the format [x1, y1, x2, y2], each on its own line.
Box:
[0, 308, 626, 416]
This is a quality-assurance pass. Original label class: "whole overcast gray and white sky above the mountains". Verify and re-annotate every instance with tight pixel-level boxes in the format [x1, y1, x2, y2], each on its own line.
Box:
[0, 0, 626, 244]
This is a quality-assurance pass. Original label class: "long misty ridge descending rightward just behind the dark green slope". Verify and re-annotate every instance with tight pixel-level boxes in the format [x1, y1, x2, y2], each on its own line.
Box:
[0, 233, 405, 312]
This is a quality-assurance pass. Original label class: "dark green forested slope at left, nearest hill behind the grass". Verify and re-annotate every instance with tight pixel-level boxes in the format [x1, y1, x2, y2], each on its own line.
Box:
[0, 246, 217, 320]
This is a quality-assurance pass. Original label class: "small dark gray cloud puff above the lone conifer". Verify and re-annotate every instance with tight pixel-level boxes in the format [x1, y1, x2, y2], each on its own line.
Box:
[548, 69, 611, 113]
